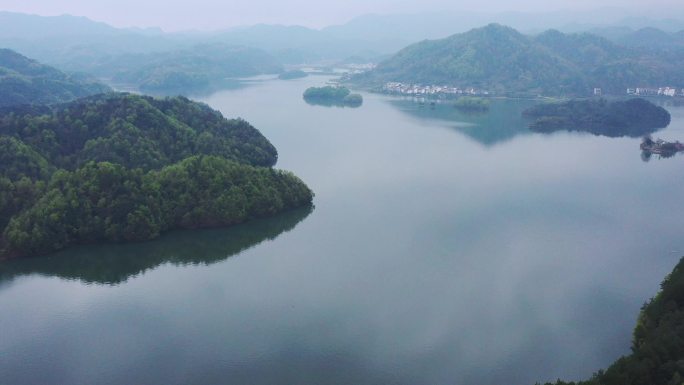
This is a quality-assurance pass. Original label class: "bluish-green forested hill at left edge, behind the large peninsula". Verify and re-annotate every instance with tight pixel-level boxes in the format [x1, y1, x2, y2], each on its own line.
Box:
[0, 49, 110, 107]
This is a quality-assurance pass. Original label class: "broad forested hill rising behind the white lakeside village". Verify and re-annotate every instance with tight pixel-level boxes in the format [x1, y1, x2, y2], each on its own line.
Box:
[352, 24, 684, 96]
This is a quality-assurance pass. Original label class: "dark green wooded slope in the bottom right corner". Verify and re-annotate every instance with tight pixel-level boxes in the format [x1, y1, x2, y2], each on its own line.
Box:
[547, 258, 684, 385]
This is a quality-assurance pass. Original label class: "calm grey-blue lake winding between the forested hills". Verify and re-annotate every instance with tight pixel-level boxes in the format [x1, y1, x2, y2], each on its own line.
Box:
[0, 76, 684, 385]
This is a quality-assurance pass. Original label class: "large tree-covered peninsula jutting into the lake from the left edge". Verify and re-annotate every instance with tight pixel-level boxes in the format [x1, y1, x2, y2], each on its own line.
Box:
[0, 94, 313, 257]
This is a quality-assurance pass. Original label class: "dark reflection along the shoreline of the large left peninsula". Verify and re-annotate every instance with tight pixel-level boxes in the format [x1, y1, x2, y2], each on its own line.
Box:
[0, 207, 313, 284]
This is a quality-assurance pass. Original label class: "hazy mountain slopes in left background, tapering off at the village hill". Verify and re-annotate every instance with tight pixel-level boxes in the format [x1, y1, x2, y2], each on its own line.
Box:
[0, 12, 396, 72]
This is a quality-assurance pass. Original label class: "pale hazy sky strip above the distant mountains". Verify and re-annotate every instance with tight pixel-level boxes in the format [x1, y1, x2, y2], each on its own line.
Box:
[0, 0, 684, 31]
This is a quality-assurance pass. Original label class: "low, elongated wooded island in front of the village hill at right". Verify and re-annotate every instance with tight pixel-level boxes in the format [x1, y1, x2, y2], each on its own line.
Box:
[523, 98, 670, 137]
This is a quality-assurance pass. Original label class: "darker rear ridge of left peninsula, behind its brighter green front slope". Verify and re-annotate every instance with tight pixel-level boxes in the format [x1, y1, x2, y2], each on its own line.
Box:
[0, 93, 278, 170]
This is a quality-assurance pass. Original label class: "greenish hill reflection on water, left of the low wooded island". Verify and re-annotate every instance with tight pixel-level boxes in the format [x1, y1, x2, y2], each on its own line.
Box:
[388, 99, 535, 146]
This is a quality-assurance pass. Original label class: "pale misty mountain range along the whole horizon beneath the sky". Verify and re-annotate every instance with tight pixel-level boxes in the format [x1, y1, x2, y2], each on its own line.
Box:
[0, 9, 684, 71]
